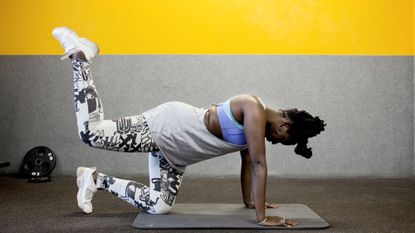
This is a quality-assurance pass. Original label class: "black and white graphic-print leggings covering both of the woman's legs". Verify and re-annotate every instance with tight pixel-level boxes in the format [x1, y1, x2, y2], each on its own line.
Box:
[72, 59, 183, 214]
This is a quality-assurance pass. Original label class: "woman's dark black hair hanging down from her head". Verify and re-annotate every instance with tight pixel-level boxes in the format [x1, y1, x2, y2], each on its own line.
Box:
[284, 108, 326, 159]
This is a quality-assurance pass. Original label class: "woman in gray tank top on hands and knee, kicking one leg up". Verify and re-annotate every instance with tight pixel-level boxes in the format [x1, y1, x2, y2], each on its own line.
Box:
[52, 27, 325, 227]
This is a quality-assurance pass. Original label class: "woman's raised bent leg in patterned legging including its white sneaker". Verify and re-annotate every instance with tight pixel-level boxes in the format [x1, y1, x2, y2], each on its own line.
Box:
[52, 27, 158, 152]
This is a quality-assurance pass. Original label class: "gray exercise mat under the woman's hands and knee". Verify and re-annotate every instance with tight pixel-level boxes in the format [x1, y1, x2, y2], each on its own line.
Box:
[133, 203, 329, 230]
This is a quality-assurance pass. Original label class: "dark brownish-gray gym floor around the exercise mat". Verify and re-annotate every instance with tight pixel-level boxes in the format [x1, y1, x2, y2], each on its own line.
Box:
[0, 176, 415, 233]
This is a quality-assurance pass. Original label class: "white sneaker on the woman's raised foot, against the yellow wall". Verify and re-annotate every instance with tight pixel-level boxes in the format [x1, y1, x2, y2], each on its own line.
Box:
[52, 27, 99, 62]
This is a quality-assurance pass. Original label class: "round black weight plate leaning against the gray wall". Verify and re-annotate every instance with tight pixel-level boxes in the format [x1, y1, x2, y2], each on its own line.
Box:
[22, 146, 56, 177]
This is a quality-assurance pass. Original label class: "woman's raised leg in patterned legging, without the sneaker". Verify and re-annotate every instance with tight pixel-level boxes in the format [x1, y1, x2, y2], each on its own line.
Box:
[72, 55, 158, 152]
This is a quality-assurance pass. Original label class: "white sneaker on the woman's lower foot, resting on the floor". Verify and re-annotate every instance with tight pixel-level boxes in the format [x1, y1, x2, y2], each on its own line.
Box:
[76, 167, 97, 214]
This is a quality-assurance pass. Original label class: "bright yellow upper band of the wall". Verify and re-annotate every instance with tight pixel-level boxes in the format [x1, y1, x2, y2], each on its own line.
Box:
[0, 0, 415, 55]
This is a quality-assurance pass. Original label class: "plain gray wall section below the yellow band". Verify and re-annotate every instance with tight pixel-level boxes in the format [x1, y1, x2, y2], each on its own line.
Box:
[0, 56, 415, 177]
